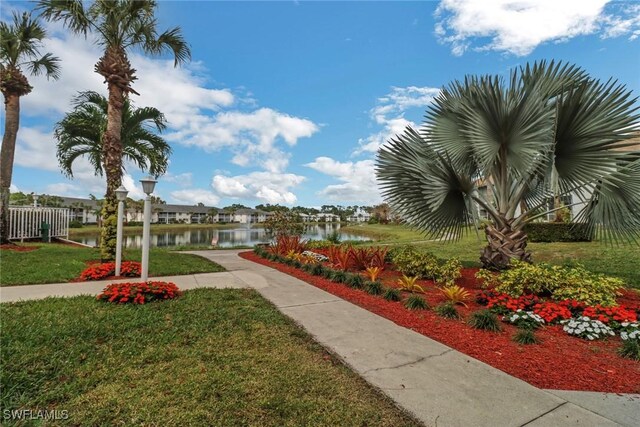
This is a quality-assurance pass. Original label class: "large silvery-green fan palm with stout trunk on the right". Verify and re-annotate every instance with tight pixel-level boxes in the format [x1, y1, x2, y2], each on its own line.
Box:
[376, 61, 640, 269]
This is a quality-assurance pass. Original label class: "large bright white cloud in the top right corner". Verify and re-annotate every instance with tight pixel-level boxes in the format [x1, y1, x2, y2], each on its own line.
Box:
[435, 0, 640, 56]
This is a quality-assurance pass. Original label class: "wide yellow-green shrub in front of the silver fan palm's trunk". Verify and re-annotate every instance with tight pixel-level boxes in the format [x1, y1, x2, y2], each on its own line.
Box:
[476, 261, 623, 306]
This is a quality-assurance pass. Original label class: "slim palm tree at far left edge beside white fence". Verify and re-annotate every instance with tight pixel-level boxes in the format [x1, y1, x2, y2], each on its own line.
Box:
[0, 12, 60, 244]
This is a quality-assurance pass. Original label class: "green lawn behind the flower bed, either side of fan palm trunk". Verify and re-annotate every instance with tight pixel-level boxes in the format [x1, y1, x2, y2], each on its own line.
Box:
[343, 224, 640, 288]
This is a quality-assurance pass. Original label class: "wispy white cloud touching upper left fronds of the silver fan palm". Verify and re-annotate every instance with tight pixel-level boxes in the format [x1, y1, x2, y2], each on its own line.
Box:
[354, 86, 440, 155]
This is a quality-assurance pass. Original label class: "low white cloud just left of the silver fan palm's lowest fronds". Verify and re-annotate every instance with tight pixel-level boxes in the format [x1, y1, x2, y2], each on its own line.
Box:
[305, 157, 382, 204]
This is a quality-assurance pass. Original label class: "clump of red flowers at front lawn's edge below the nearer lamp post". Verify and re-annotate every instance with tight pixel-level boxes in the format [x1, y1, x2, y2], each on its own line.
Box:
[96, 282, 181, 304]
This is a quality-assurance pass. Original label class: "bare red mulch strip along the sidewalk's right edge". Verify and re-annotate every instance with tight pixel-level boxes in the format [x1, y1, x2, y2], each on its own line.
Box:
[240, 252, 640, 393]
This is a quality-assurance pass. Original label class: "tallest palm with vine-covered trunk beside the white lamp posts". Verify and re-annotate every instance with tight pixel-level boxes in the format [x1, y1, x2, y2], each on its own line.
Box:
[38, 0, 191, 260]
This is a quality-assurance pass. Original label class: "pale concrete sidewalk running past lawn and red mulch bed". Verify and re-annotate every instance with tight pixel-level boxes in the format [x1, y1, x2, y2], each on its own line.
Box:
[0, 251, 640, 426]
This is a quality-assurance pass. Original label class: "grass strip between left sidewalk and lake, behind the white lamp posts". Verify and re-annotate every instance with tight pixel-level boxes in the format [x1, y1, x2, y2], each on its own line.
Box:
[0, 243, 224, 286]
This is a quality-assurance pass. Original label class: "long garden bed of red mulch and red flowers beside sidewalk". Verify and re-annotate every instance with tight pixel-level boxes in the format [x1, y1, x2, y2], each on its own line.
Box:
[241, 239, 640, 393]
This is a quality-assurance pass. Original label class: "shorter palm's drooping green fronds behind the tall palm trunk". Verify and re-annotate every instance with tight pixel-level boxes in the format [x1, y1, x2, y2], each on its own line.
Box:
[54, 91, 171, 181]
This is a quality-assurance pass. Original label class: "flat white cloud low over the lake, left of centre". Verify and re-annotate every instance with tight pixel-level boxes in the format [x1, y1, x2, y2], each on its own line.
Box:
[211, 172, 305, 205]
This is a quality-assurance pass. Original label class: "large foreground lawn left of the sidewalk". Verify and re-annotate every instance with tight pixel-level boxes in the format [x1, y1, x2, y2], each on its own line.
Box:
[0, 289, 419, 426]
